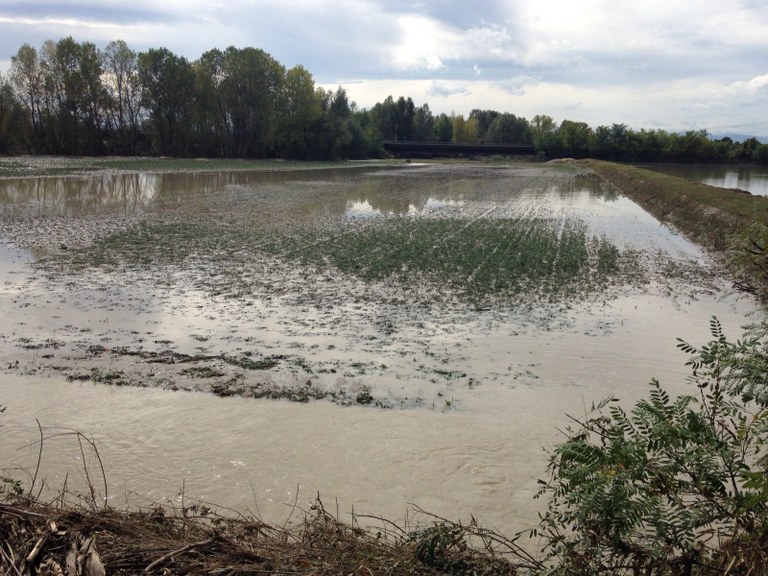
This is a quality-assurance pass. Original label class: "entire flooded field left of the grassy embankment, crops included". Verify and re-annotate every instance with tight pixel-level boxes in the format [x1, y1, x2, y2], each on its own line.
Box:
[0, 164, 753, 533]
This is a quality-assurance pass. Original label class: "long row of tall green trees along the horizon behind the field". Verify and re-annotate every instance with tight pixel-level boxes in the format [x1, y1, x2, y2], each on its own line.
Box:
[0, 37, 768, 163]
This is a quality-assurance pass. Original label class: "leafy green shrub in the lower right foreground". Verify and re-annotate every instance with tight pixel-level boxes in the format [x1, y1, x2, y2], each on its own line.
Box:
[534, 319, 768, 575]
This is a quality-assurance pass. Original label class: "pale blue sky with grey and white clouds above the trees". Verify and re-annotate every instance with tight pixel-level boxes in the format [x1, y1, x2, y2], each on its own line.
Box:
[0, 0, 768, 142]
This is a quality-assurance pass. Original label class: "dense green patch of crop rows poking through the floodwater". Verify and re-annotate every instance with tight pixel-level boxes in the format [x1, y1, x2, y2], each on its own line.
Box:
[286, 218, 632, 299]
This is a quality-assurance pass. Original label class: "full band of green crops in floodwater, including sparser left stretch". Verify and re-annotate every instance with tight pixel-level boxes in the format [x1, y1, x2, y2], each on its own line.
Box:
[61, 217, 645, 303]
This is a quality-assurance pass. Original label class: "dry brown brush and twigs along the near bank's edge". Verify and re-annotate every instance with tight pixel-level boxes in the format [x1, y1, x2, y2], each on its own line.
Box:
[0, 494, 534, 576]
